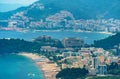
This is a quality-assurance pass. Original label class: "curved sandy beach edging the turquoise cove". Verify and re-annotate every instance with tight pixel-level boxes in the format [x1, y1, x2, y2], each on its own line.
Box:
[18, 53, 60, 79]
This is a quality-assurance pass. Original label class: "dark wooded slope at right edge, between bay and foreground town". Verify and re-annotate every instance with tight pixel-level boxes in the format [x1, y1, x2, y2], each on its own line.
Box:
[94, 33, 120, 49]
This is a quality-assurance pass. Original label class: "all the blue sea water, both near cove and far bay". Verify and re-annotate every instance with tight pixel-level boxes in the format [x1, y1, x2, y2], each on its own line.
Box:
[0, 31, 112, 79]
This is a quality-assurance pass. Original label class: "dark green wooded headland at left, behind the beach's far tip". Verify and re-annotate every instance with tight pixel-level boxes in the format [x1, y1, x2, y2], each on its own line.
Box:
[0, 39, 41, 54]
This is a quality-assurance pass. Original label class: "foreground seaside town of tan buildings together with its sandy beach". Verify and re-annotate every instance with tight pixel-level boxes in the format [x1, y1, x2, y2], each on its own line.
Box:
[16, 36, 120, 79]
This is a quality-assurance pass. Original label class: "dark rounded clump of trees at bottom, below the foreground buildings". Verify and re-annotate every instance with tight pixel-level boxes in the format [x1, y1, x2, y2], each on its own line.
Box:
[56, 68, 88, 79]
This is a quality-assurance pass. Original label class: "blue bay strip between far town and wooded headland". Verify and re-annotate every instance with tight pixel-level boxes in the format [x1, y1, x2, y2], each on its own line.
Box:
[0, 31, 110, 44]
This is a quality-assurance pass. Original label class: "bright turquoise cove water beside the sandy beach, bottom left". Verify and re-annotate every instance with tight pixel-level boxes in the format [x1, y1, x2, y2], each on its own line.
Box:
[0, 55, 43, 79]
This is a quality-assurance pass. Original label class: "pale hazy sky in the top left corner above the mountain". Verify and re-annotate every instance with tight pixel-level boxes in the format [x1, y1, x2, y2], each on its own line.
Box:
[0, 0, 37, 5]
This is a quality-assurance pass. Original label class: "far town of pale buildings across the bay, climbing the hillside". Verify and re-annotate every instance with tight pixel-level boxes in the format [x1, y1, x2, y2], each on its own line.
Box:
[0, 3, 120, 33]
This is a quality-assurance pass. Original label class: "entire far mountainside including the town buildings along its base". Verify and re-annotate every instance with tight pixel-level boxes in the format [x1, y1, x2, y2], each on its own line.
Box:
[0, 0, 120, 33]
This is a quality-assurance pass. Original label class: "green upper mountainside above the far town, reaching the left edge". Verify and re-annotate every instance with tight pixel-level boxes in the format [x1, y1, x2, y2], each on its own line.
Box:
[0, 0, 120, 19]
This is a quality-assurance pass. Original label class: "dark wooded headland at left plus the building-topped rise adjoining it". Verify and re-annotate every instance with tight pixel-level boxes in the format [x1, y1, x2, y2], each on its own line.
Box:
[0, 36, 62, 54]
